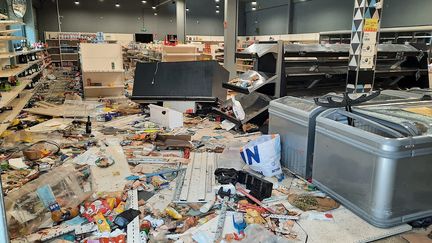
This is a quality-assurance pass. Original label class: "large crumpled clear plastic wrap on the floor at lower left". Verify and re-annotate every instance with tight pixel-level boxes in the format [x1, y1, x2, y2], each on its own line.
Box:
[5, 166, 92, 238]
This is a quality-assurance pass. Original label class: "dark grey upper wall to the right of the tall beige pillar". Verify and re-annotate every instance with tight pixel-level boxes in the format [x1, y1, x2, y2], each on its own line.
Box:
[245, 0, 432, 35]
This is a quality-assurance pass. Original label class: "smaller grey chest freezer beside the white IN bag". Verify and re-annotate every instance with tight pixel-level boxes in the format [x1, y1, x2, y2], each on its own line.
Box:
[269, 96, 325, 179]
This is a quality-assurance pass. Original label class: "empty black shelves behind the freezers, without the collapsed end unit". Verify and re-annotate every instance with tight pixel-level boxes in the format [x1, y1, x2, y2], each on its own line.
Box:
[284, 44, 429, 96]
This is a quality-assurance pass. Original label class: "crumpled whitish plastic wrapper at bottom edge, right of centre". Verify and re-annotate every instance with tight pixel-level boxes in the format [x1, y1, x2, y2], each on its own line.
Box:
[241, 224, 290, 243]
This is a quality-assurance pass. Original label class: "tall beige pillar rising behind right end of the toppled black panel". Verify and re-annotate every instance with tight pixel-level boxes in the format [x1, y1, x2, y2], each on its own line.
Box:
[224, 0, 238, 79]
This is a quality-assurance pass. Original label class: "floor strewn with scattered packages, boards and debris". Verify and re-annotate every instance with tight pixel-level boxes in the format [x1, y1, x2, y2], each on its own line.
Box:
[1, 70, 430, 243]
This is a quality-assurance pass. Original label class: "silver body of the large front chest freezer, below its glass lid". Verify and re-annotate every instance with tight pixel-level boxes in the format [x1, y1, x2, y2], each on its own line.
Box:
[313, 109, 432, 228]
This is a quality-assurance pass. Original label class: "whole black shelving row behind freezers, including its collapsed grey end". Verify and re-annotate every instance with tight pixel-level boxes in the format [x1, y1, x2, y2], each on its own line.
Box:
[218, 43, 429, 125]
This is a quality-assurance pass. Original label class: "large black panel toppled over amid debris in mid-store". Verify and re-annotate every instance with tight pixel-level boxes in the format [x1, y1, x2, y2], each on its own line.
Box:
[131, 61, 229, 103]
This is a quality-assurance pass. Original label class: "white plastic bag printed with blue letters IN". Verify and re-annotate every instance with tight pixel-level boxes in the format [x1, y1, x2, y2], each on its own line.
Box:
[240, 134, 282, 176]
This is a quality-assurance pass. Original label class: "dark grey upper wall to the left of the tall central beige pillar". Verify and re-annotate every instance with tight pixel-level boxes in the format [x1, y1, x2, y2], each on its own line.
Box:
[34, 0, 223, 38]
